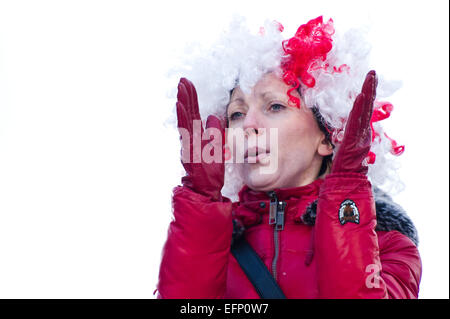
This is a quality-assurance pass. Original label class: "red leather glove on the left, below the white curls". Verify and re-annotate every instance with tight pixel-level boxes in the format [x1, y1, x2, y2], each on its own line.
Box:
[176, 78, 225, 201]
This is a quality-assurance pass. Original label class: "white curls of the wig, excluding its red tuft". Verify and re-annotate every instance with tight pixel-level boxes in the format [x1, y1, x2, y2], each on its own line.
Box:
[166, 17, 403, 201]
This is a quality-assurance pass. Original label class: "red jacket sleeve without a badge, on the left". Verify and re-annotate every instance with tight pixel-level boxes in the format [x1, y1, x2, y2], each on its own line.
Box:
[158, 186, 233, 299]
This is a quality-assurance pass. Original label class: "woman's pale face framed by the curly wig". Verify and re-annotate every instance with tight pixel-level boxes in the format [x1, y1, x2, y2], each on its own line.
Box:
[227, 73, 332, 191]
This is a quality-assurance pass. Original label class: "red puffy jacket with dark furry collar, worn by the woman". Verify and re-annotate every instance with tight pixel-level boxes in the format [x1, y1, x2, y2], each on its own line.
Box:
[158, 173, 422, 298]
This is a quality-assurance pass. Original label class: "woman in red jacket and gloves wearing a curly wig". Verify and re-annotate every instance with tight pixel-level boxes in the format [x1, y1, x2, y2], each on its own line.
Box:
[158, 17, 421, 298]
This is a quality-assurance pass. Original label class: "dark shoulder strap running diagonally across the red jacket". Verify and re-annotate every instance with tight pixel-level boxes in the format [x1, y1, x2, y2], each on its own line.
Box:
[231, 238, 286, 299]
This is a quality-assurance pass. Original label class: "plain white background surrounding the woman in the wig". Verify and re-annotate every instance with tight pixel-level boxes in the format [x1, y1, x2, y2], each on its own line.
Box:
[0, 0, 449, 298]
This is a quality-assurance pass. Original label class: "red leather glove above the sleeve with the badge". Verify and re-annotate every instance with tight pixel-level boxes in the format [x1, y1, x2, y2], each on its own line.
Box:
[331, 71, 378, 175]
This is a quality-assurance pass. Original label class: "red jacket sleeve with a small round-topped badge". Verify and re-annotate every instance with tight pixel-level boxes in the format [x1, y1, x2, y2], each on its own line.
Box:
[316, 173, 421, 299]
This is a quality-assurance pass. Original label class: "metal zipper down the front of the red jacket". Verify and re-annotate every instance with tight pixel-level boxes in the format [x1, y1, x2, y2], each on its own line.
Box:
[268, 191, 286, 281]
